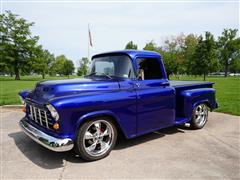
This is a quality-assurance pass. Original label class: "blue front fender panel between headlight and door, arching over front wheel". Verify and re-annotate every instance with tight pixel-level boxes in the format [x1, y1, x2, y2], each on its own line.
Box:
[50, 90, 136, 138]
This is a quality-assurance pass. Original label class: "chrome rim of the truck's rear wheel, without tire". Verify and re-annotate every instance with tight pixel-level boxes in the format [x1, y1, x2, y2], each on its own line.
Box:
[193, 104, 208, 127]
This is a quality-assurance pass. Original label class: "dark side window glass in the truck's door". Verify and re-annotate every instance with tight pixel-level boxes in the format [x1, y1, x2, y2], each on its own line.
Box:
[137, 58, 162, 80]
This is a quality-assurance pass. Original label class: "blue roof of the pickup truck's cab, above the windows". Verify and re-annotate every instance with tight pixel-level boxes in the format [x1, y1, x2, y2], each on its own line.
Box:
[92, 50, 160, 59]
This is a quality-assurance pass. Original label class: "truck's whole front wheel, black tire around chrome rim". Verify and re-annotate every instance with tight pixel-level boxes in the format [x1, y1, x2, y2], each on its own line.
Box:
[74, 117, 117, 161]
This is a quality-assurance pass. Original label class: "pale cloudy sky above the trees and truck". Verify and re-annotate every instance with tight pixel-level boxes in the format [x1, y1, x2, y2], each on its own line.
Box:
[1, 0, 239, 66]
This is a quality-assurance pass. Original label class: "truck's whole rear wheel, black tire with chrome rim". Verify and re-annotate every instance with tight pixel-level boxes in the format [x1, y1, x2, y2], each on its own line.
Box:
[190, 104, 208, 129]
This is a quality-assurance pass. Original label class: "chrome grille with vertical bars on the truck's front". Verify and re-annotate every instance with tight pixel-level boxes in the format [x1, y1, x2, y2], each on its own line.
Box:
[27, 104, 53, 129]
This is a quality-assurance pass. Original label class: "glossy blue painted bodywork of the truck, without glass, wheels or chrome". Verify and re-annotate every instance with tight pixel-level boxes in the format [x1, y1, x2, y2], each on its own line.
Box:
[19, 50, 216, 140]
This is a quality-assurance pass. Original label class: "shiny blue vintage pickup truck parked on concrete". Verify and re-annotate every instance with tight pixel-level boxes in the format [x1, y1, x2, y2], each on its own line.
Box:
[19, 50, 217, 161]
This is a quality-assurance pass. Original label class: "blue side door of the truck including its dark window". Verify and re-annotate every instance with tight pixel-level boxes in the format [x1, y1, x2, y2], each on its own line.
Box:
[134, 57, 175, 134]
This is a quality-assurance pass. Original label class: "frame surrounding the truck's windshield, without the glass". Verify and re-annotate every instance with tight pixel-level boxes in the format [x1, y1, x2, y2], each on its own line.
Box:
[87, 53, 137, 79]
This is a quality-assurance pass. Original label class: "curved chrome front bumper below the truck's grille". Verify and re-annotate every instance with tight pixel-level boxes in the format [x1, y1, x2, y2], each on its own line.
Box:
[19, 118, 73, 152]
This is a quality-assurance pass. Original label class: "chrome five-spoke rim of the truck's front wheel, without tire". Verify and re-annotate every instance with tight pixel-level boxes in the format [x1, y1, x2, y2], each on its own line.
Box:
[83, 120, 114, 157]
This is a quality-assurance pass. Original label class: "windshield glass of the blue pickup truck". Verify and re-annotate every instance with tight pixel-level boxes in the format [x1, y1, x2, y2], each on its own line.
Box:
[90, 55, 135, 78]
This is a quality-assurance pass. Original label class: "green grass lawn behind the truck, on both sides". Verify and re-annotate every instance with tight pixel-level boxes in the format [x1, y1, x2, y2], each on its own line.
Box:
[0, 76, 240, 116]
